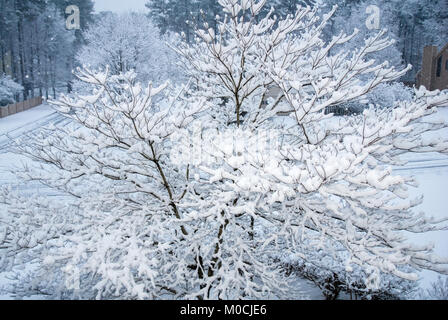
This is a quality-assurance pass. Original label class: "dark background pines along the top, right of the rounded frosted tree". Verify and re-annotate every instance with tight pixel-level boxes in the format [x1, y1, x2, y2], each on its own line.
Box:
[146, 0, 448, 81]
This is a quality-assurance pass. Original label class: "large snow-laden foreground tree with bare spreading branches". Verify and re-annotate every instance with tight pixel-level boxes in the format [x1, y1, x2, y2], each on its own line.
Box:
[0, 0, 448, 299]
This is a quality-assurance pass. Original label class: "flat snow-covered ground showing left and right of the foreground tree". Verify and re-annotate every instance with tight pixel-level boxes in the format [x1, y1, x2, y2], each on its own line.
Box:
[0, 104, 448, 299]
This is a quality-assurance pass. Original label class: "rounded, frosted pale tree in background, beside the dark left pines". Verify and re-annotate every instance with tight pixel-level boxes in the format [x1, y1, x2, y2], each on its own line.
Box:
[77, 13, 180, 83]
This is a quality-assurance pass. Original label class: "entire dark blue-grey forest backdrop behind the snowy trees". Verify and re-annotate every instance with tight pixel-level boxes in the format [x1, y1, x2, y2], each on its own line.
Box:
[0, 0, 448, 100]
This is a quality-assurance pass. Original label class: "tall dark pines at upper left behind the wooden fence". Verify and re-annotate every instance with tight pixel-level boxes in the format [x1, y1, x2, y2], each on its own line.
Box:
[0, 0, 93, 99]
